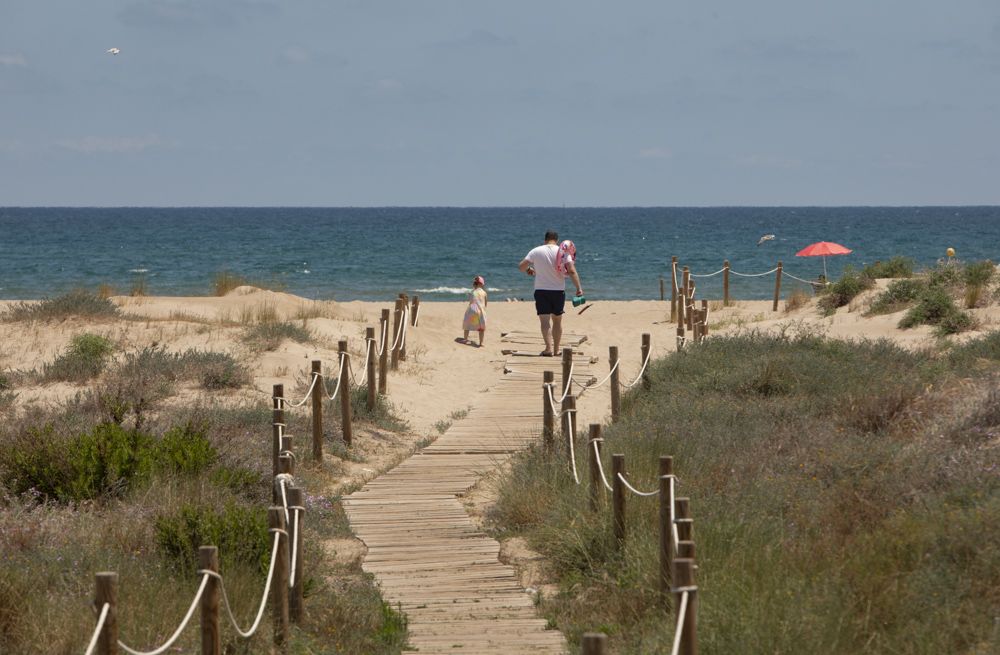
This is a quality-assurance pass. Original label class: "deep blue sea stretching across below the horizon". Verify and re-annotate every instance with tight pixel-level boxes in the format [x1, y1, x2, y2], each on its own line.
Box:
[0, 207, 1000, 301]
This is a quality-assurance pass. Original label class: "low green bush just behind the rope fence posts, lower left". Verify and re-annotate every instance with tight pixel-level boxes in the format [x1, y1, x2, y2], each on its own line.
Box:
[154, 503, 271, 574]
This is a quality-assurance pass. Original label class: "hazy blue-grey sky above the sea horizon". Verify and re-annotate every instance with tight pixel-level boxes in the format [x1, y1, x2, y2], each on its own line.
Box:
[0, 0, 1000, 206]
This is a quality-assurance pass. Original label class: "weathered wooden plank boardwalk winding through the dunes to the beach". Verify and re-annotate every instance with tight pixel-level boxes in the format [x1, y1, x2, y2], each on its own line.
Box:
[344, 333, 590, 653]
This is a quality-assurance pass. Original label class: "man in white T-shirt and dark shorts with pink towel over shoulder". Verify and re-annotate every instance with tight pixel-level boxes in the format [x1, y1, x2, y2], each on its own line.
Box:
[518, 230, 583, 357]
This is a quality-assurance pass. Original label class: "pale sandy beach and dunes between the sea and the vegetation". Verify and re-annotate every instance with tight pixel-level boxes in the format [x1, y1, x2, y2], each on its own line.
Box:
[0, 281, 1000, 436]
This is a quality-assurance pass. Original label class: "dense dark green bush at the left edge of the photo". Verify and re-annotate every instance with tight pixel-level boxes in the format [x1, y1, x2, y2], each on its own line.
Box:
[0, 423, 153, 502]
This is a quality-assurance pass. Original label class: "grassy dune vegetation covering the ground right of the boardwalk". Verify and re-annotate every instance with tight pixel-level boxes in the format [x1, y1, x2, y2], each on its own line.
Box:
[491, 328, 1000, 654]
